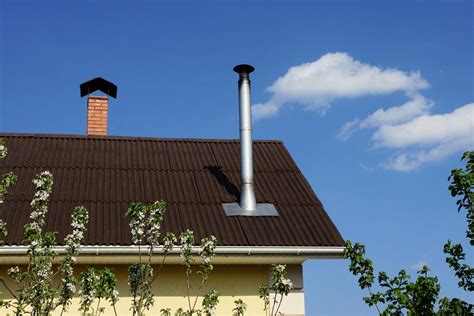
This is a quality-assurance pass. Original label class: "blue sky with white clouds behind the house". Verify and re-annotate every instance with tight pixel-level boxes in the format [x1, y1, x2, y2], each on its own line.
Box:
[0, 1, 474, 315]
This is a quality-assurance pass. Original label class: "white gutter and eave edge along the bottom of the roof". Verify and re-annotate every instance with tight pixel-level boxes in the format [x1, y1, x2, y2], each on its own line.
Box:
[0, 245, 344, 265]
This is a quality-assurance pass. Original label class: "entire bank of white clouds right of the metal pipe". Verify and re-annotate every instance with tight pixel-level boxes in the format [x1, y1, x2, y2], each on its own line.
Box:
[253, 53, 474, 172]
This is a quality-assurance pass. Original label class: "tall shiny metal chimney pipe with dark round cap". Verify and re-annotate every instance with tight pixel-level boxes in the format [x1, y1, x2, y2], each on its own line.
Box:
[234, 64, 257, 211]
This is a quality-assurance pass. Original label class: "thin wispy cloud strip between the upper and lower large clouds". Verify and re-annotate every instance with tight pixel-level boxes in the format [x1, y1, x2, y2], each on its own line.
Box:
[338, 93, 434, 140]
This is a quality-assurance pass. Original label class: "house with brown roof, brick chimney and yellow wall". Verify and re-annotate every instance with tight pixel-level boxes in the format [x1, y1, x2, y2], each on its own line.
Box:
[0, 68, 344, 315]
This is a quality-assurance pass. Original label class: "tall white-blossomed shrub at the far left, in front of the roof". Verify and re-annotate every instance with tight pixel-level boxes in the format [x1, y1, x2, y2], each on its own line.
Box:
[1, 171, 88, 315]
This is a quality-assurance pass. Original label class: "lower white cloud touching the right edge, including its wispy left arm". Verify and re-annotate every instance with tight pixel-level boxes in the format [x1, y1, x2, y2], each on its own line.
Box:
[338, 94, 474, 172]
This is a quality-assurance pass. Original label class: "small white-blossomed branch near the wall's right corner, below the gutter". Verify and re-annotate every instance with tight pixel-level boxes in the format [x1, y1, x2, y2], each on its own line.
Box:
[259, 264, 293, 315]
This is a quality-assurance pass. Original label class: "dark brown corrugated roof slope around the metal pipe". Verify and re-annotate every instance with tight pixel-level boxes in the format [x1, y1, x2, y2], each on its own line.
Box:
[0, 134, 343, 246]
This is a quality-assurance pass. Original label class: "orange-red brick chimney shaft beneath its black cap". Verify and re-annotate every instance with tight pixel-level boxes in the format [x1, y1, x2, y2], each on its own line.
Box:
[87, 95, 109, 136]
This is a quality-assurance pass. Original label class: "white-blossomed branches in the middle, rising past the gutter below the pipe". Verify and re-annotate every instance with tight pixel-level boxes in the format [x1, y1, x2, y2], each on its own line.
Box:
[125, 201, 219, 315]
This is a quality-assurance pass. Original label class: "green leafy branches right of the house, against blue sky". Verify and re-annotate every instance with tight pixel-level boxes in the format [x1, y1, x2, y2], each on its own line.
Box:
[344, 152, 474, 315]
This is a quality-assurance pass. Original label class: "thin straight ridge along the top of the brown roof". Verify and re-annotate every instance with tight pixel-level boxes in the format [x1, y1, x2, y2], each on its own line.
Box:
[0, 133, 283, 143]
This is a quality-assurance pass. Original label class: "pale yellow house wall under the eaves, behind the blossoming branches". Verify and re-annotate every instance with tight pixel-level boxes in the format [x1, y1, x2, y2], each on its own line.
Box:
[0, 265, 278, 316]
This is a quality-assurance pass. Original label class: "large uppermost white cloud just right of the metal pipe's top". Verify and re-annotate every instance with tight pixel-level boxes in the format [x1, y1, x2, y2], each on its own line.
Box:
[253, 53, 429, 119]
